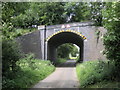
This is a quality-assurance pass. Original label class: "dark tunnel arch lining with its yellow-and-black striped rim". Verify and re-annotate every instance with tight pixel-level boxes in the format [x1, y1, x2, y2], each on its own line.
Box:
[47, 30, 86, 62]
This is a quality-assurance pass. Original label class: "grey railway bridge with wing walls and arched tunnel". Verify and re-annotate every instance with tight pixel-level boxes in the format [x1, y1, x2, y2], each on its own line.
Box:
[17, 22, 106, 61]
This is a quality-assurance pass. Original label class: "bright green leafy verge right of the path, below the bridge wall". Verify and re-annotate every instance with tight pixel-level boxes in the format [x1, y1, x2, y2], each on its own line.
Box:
[76, 61, 116, 87]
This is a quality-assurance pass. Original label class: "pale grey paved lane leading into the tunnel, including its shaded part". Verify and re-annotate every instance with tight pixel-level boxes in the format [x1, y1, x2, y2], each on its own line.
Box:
[33, 60, 79, 88]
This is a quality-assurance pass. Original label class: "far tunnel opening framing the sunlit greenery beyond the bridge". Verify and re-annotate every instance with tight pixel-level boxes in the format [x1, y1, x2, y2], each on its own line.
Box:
[57, 43, 80, 60]
